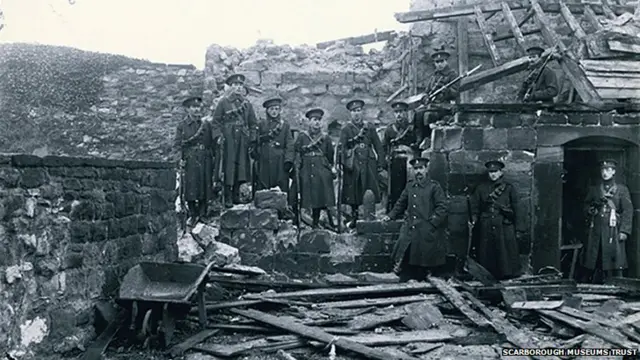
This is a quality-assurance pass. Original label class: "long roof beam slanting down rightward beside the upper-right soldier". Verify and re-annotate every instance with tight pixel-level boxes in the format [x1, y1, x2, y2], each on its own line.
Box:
[531, 0, 602, 103]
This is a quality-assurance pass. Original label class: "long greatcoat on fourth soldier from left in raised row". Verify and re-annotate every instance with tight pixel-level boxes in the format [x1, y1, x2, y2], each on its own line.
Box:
[294, 132, 336, 209]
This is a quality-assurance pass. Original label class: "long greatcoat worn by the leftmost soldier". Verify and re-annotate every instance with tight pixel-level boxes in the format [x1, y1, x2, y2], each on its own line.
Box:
[174, 116, 214, 201]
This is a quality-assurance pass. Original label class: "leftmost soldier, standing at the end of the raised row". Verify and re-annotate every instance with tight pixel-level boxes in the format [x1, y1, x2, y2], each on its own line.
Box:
[174, 97, 214, 225]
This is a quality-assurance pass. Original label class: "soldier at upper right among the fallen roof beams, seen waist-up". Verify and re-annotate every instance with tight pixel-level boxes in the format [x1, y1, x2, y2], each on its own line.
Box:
[518, 46, 558, 102]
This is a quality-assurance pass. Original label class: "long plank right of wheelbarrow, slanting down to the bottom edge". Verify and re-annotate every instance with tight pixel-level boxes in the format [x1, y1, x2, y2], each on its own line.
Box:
[231, 309, 422, 360]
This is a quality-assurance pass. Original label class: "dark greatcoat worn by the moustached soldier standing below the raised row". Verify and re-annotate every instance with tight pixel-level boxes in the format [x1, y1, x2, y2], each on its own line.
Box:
[389, 178, 448, 267]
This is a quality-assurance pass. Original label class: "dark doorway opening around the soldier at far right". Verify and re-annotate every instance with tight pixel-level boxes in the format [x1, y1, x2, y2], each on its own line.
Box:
[560, 137, 639, 280]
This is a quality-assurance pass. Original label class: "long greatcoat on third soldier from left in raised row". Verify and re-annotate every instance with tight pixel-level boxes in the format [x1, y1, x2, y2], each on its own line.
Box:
[256, 119, 294, 192]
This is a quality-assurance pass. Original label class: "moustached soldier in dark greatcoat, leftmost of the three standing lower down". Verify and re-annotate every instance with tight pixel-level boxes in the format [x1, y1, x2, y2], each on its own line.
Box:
[383, 157, 449, 282]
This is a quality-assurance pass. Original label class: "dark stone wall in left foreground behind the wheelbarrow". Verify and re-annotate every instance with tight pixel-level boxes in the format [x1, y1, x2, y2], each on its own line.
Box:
[0, 155, 176, 358]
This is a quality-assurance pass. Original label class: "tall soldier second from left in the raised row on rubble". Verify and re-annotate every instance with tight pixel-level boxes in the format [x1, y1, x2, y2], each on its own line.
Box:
[213, 74, 258, 207]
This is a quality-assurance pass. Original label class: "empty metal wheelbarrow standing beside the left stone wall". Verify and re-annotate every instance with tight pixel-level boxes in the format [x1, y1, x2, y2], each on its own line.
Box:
[116, 262, 213, 347]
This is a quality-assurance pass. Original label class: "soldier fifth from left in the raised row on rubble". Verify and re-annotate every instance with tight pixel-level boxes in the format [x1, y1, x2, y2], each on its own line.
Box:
[338, 100, 385, 228]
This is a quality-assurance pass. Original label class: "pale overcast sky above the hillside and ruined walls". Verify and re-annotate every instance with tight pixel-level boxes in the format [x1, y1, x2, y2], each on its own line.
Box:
[0, 0, 410, 68]
